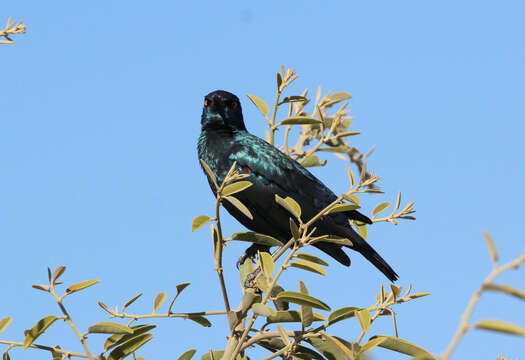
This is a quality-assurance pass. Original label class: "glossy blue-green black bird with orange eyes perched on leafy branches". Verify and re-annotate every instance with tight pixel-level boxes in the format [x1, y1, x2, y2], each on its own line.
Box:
[197, 90, 398, 281]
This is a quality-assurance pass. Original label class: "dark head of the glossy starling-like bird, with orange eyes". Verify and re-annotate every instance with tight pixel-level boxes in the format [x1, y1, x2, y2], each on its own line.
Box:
[201, 90, 246, 130]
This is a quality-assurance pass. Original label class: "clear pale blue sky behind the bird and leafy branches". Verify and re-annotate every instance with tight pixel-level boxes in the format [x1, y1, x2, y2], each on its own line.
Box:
[0, 1, 525, 359]
